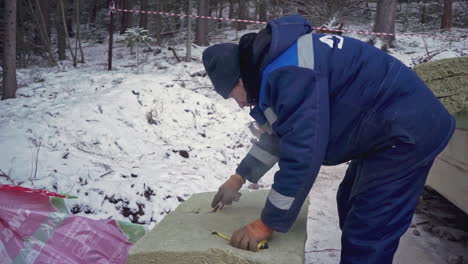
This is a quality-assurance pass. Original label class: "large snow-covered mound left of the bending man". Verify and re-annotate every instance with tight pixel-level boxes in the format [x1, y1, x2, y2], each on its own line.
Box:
[0, 40, 262, 229]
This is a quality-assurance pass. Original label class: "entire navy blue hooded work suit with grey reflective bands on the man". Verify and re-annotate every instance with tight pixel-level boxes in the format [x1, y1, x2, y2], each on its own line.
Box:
[236, 15, 455, 264]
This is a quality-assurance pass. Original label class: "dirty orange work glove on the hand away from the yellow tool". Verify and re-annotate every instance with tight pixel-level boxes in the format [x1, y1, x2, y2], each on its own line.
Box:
[211, 173, 245, 211]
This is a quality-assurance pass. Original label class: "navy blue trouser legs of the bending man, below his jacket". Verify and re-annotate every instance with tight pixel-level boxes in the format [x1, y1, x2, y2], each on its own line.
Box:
[337, 159, 433, 264]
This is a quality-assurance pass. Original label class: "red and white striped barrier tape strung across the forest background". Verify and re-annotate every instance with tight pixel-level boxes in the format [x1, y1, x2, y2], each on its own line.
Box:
[111, 7, 467, 40]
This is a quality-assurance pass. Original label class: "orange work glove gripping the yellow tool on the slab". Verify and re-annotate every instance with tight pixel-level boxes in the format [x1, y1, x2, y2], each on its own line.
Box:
[231, 218, 273, 251]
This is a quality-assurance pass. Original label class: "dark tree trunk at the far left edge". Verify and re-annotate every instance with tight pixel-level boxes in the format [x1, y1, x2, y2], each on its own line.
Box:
[2, 1, 17, 100]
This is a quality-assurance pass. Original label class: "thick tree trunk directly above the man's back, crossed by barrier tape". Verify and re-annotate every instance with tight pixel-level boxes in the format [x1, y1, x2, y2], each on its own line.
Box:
[374, 0, 396, 47]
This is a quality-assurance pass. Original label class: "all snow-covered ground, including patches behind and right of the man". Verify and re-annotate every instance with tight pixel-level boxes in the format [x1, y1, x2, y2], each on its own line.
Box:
[0, 24, 468, 263]
